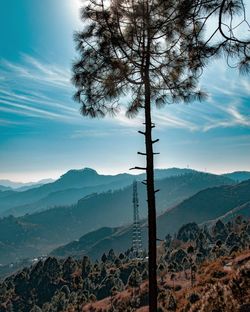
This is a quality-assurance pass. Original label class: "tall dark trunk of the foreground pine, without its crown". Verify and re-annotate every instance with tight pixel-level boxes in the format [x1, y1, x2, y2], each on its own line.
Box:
[144, 72, 157, 312]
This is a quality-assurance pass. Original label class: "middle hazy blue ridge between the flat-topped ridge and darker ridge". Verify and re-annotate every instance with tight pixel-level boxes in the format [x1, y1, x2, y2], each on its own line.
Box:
[0, 172, 234, 263]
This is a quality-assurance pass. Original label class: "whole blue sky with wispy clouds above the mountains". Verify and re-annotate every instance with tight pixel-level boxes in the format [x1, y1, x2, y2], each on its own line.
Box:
[0, 0, 250, 181]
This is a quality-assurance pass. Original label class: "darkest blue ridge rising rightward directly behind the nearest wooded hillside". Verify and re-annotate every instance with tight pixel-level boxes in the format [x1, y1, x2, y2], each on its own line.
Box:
[51, 180, 250, 259]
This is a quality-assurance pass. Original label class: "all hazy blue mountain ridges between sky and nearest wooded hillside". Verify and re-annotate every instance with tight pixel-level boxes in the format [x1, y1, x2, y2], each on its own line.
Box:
[0, 168, 250, 265]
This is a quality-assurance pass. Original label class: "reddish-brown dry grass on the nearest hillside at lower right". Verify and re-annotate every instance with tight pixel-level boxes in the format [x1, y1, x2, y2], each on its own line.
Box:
[82, 250, 250, 312]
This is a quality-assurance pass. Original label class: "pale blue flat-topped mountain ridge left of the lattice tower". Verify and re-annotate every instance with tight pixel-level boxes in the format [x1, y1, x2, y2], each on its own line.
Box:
[1, 168, 133, 215]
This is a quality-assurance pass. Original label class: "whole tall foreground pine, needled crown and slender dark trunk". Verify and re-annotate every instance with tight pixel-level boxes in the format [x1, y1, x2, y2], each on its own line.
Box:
[73, 0, 249, 312]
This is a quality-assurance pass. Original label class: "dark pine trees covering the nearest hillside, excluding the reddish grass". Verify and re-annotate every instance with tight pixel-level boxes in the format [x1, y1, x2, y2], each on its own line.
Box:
[0, 217, 250, 312]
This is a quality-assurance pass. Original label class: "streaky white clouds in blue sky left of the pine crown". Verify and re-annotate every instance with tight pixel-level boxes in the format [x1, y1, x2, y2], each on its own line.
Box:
[0, 55, 80, 122]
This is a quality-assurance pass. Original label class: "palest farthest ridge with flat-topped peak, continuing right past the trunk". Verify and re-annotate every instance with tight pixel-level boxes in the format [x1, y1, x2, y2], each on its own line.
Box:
[0, 168, 195, 216]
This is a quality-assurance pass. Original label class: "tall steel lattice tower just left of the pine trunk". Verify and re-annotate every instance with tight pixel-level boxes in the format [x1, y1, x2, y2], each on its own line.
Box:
[132, 180, 143, 258]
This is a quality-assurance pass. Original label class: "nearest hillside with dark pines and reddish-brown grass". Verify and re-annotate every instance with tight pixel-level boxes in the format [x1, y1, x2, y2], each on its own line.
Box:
[0, 217, 250, 312]
